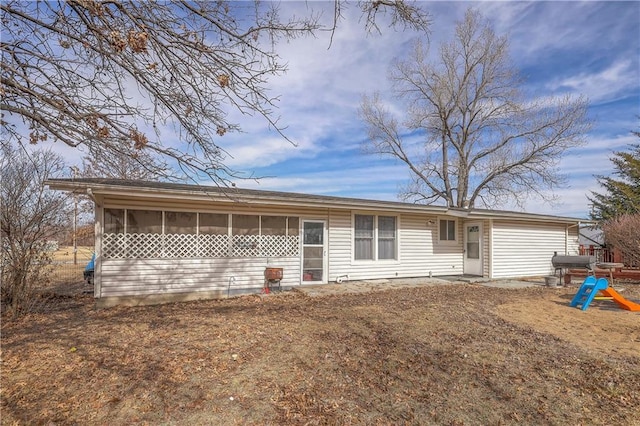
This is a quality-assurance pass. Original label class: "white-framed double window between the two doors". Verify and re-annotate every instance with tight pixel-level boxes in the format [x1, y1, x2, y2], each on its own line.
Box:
[354, 214, 398, 260]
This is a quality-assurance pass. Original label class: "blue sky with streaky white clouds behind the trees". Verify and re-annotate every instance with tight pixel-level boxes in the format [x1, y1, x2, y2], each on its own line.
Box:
[52, 2, 640, 217]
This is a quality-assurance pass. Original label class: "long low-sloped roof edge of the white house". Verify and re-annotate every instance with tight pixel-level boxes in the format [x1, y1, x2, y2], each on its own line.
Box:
[45, 178, 591, 223]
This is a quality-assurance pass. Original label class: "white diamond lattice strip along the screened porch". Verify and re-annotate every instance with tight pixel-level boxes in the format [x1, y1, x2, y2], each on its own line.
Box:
[102, 234, 300, 259]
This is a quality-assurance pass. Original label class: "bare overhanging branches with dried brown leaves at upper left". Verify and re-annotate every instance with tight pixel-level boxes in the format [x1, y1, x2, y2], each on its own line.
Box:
[0, 0, 429, 183]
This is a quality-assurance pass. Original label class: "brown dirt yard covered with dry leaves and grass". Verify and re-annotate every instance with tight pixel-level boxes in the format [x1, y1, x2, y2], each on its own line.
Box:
[1, 282, 640, 425]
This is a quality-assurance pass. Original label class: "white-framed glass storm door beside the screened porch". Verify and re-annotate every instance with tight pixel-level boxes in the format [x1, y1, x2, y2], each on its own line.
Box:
[302, 220, 327, 284]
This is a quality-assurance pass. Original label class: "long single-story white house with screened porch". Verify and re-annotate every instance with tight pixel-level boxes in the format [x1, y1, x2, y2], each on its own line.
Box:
[47, 179, 581, 306]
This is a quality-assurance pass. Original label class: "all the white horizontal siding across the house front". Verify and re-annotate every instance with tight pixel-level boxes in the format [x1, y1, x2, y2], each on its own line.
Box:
[96, 195, 578, 297]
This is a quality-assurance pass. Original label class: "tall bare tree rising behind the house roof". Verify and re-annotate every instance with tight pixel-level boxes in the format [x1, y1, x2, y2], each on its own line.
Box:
[360, 10, 589, 207]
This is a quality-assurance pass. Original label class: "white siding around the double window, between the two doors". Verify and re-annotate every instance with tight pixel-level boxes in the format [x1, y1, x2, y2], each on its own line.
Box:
[329, 210, 463, 281]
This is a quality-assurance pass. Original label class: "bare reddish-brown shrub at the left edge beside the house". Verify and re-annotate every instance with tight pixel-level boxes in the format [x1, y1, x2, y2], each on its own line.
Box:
[0, 143, 71, 315]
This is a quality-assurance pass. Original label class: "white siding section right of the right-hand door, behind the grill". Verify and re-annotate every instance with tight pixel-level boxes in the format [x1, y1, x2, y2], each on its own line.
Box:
[491, 220, 567, 278]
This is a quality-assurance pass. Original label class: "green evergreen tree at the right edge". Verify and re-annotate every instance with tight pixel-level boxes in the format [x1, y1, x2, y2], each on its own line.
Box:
[589, 140, 640, 221]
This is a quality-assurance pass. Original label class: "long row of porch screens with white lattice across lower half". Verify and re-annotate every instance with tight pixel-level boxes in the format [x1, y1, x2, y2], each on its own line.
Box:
[102, 208, 300, 259]
